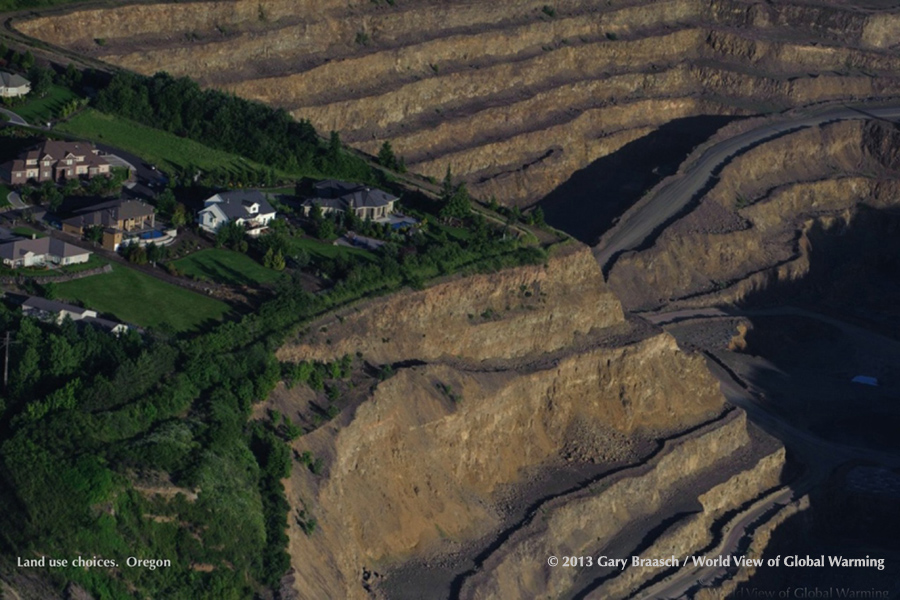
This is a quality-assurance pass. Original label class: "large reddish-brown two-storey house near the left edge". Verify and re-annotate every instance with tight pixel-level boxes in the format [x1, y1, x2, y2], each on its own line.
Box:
[0, 140, 110, 185]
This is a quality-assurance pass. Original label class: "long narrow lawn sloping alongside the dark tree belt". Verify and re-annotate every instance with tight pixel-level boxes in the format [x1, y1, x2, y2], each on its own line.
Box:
[56, 109, 292, 175]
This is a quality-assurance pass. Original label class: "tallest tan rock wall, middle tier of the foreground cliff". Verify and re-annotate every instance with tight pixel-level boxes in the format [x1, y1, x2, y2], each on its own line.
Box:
[289, 334, 728, 598]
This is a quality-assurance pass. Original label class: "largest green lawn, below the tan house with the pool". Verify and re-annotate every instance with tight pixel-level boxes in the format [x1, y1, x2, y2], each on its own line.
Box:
[56, 265, 229, 332]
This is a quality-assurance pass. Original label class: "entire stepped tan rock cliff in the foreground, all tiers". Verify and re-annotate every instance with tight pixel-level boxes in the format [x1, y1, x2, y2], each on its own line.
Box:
[279, 247, 783, 598]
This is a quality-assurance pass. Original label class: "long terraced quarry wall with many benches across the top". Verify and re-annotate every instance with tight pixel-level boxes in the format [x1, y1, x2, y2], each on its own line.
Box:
[15, 0, 900, 205]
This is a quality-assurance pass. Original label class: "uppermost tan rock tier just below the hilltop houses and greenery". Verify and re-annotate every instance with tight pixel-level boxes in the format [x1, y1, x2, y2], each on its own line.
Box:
[278, 245, 623, 363]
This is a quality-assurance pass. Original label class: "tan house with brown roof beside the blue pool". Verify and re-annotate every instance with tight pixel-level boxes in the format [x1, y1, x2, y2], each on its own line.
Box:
[62, 200, 156, 251]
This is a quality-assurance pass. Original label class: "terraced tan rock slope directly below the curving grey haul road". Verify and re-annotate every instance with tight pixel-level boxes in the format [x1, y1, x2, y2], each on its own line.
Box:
[609, 121, 900, 309]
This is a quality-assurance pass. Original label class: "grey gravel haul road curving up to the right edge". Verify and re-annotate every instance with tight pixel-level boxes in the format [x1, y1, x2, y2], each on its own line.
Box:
[594, 106, 900, 272]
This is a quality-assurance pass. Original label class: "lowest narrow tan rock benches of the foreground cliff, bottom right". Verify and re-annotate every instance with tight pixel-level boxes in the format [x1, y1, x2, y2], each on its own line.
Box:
[462, 414, 784, 598]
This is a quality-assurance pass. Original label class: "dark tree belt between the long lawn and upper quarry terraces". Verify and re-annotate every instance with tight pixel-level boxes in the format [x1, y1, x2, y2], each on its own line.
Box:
[94, 72, 373, 181]
